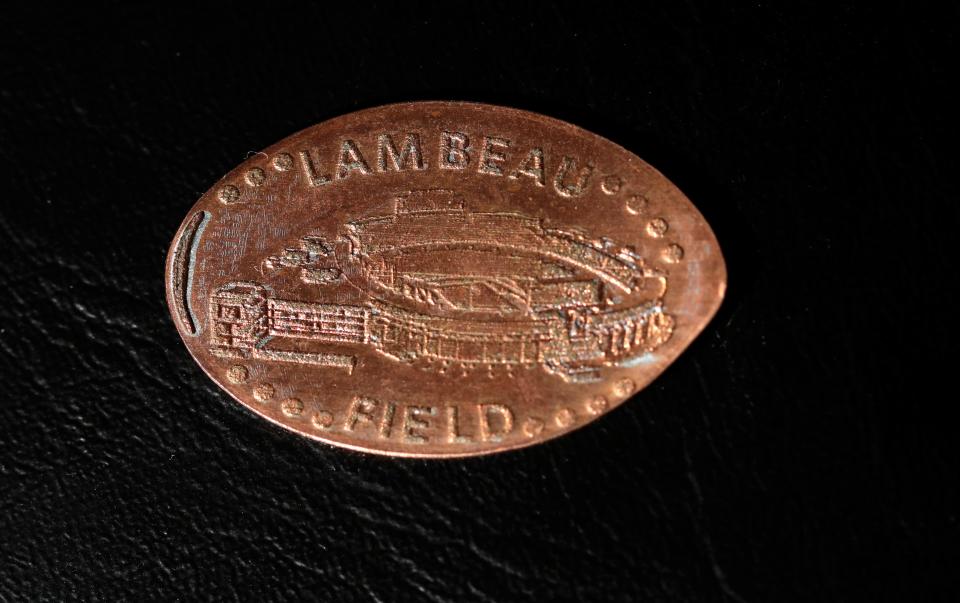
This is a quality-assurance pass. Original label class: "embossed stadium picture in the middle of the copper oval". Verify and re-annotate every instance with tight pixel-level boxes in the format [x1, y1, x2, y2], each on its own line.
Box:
[209, 190, 674, 382]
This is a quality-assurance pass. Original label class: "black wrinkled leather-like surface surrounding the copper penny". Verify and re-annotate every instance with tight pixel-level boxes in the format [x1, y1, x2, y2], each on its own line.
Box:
[0, 2, 960, 601]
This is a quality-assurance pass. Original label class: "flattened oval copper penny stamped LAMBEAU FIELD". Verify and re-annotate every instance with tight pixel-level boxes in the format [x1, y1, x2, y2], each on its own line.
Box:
[166, 102, 726, 457]
